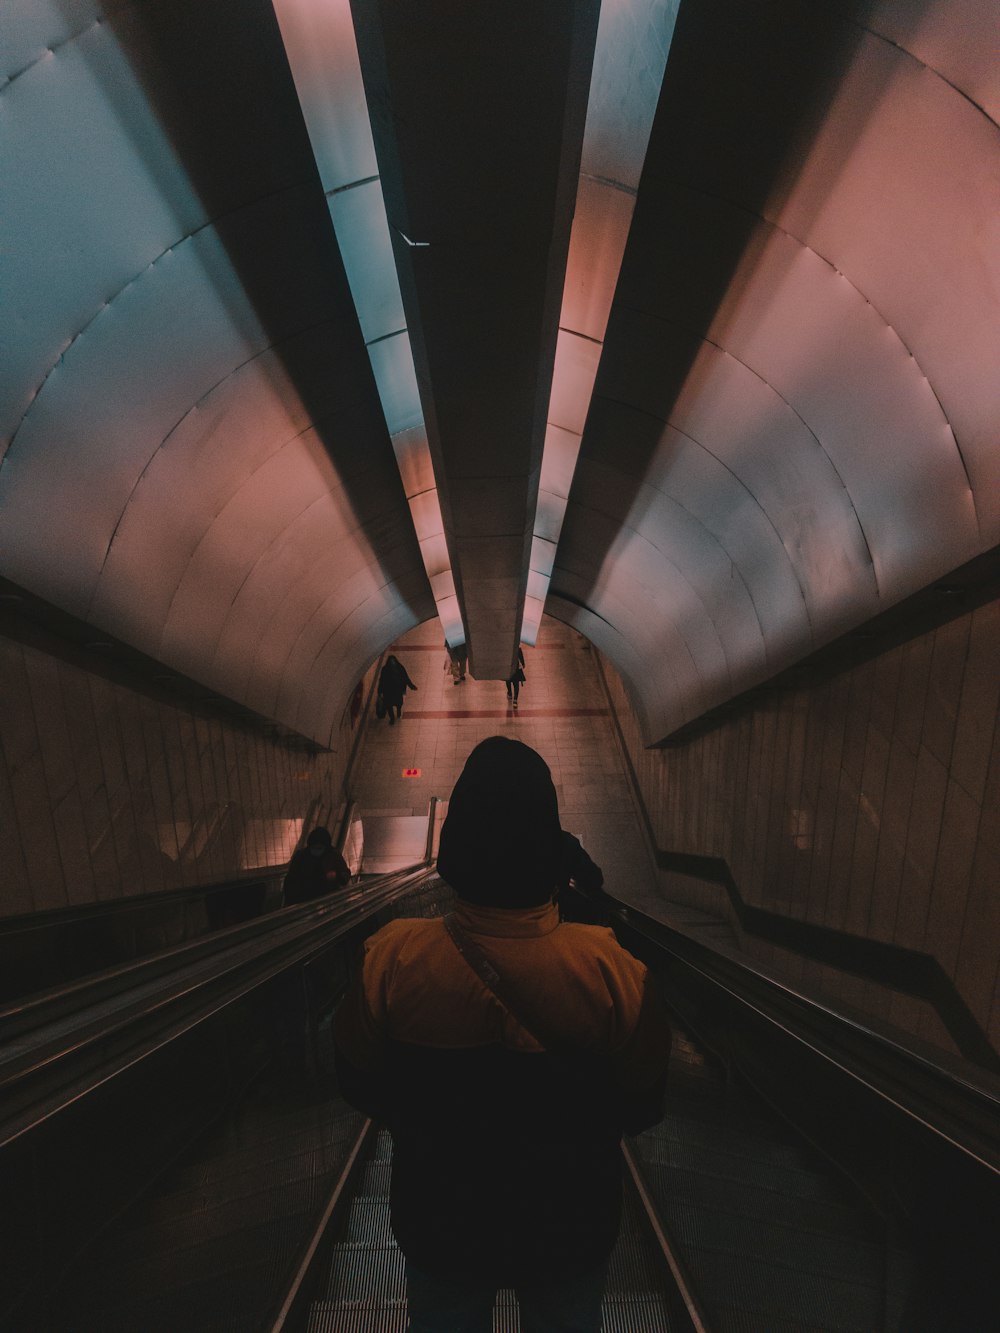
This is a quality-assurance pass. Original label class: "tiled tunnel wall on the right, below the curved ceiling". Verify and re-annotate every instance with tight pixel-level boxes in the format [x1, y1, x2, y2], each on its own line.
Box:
[604, 603, 1000, 1048]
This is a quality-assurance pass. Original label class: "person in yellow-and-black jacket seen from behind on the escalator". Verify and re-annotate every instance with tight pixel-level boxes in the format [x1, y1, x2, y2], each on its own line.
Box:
[333, 736, 671, 1333]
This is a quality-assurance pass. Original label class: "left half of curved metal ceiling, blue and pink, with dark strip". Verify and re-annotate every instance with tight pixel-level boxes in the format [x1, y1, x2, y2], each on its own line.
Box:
[0, 0, 433, 737]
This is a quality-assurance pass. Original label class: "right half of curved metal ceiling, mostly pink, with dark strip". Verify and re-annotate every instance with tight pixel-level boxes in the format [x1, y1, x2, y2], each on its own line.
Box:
[553, 0, 1000, 740]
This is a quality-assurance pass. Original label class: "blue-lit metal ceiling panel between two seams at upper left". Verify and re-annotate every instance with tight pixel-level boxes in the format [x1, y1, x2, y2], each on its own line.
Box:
[0, 16, 207, 451]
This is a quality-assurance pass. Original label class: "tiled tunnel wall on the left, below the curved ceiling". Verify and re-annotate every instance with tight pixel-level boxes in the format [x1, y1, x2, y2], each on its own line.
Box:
[0, 639, 372, 917]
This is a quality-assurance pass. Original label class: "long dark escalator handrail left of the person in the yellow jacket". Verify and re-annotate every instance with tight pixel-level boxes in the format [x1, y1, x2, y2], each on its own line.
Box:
[0, 861, 436, 1146]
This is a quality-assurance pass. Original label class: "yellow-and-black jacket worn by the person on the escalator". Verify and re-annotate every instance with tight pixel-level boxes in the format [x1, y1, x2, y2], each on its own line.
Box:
[333, 902, 669, 1281]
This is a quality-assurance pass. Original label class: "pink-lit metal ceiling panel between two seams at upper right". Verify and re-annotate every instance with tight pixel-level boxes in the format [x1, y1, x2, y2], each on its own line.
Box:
[768, 24, 1000, 545]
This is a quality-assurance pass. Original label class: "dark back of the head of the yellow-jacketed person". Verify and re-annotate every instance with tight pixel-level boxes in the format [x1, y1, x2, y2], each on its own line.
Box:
[437, 736, 561, 908]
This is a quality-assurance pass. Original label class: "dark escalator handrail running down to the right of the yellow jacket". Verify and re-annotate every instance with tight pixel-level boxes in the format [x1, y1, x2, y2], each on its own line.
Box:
[593, 892, 1000, 1174]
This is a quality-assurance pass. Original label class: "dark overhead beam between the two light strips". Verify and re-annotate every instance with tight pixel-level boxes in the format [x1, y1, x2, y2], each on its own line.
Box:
[352, 0, 599, 680]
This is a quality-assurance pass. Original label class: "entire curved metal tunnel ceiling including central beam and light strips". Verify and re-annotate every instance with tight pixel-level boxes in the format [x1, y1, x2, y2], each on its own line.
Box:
[0, 0, 1000, 744]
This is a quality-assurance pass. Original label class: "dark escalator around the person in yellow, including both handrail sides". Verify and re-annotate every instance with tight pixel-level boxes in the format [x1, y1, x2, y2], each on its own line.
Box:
[0, 826, 1000, 1333]
